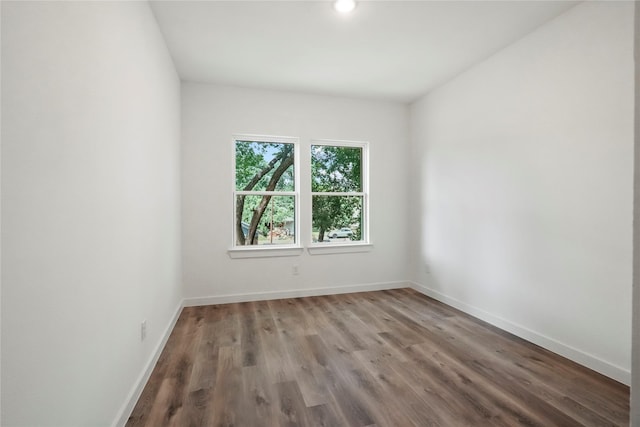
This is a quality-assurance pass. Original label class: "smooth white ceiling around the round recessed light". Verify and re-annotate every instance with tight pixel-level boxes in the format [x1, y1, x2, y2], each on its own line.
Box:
[151, 0, 578, 102]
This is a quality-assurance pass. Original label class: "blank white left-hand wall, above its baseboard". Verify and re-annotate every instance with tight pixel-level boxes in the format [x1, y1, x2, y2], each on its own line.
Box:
[1, 1, 181, 427]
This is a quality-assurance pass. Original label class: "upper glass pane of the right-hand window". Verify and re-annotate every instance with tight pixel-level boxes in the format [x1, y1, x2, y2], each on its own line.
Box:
[311, 145, 362, 193]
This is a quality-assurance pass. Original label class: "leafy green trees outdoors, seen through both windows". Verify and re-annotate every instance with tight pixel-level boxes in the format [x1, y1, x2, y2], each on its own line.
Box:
[235, 141, 363, 244]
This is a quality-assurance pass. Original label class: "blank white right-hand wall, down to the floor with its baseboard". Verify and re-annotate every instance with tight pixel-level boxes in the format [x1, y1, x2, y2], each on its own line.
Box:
[411, 2, 634, 383]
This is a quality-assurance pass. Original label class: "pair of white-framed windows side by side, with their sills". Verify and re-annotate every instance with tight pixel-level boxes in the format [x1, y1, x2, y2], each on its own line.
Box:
[229, 135, 371, 258]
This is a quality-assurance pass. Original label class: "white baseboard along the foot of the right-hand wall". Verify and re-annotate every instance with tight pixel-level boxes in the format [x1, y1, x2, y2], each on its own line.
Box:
[410, 282, 631, 385]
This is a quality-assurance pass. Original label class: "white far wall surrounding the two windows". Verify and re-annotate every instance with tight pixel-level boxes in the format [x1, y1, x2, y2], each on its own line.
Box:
[182, 83, 408, 303]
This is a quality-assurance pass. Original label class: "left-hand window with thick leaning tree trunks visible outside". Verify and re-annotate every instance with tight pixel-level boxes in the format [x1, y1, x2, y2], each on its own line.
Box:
[233, 135, 298, 248]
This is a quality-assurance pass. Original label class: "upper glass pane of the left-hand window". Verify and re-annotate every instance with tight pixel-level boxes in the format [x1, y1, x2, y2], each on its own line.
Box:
[236, 141, 295, 191]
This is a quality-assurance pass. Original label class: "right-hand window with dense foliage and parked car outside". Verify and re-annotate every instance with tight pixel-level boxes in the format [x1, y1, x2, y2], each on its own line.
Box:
[311, 141, 368, 244]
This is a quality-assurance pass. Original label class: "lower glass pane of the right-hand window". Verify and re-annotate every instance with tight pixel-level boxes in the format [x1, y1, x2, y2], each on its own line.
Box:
[311, 196, 363, 243]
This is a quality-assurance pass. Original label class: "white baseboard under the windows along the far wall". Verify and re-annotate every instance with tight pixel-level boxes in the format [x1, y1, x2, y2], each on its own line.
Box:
[183, 282, 410, 307]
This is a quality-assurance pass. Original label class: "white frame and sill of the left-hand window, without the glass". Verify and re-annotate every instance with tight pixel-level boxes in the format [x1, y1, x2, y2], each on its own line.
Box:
[228, 134, 303, 258]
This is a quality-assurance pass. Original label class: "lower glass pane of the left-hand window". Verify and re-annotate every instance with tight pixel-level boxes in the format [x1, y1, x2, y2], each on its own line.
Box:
[235, 196, 296, 246]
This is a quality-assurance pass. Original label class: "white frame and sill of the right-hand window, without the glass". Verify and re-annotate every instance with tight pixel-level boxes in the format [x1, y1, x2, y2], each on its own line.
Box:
[307, 139, 372, 255]
